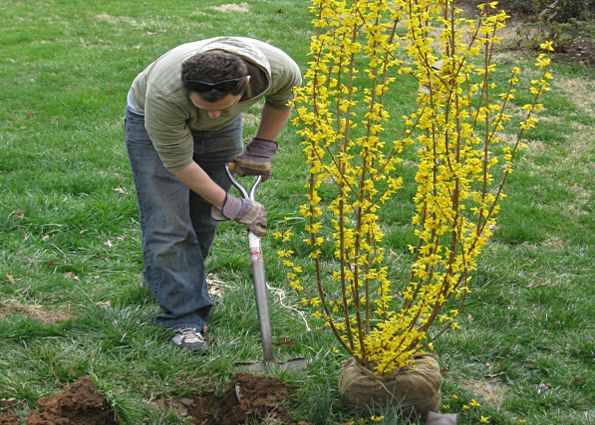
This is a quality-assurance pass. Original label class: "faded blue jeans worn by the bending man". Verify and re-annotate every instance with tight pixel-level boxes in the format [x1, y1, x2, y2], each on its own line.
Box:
[124, 110, 242, 331]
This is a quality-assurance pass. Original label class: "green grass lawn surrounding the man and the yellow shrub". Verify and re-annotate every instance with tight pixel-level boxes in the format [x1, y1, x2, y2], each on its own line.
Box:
[0, 0, 595, 425]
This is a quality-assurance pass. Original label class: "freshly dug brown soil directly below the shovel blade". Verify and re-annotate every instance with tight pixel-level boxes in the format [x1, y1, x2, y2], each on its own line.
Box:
[160, 373, 310, 425]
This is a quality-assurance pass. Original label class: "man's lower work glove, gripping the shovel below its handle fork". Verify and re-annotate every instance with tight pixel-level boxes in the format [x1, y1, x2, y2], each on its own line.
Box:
[211, 193, 267, 236]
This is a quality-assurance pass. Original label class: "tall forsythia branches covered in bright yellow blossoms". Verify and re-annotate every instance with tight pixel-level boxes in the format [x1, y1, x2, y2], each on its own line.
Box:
[278, 0, 551, 375]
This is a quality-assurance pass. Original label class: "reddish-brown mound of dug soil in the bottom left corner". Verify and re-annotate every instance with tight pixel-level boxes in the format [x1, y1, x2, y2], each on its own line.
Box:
[27, 379, 120, 425]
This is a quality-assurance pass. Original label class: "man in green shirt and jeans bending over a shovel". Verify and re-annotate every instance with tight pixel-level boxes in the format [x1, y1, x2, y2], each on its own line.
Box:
[125, 37, 301, 351]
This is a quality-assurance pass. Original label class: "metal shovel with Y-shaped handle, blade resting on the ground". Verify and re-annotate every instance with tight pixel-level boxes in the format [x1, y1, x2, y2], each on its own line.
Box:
[225, 166, 307, 372]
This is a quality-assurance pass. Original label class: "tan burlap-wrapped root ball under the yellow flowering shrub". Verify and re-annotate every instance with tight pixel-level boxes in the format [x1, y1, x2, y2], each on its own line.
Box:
[339, 356, 442, 416]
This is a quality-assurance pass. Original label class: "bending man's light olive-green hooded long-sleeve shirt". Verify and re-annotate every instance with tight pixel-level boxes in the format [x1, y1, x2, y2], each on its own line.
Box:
[128, 37, 301, 170]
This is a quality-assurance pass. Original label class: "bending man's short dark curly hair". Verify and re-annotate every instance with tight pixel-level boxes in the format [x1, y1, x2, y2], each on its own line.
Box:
[182, 50, 248, 102]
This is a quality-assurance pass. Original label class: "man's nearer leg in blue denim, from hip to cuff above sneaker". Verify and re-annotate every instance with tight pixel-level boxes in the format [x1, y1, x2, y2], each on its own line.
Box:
[125, 112, 212, 331]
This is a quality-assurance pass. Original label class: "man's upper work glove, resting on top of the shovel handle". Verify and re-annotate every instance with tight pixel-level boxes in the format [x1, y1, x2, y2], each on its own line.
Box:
[229, 137, 278, 181]
